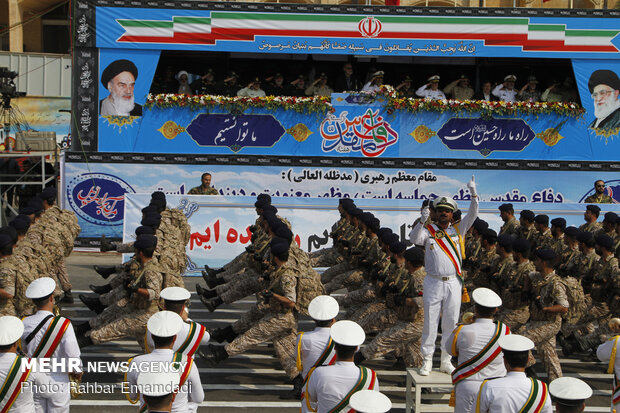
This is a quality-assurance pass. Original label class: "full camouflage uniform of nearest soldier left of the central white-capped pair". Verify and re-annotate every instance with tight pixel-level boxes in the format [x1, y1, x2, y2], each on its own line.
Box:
[224, 263, 299, 379]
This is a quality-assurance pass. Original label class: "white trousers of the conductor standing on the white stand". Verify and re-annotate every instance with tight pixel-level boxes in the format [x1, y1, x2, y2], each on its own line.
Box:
[422, 274, 462, 357]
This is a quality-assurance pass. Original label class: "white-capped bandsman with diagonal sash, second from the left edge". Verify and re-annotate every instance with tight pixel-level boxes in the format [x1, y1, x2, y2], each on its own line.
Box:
[22, 277, 82, 413]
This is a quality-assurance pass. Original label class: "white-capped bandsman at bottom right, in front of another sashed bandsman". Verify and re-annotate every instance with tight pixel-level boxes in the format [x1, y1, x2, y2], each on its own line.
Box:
[476, 334, 552, 413]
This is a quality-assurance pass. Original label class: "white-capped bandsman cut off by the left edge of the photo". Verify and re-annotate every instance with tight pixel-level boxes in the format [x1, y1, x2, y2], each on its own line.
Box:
[0, 316, 49, 413]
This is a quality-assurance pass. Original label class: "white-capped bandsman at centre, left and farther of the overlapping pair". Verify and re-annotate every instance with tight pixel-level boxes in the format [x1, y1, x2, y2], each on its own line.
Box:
[293, 295, 340, 413]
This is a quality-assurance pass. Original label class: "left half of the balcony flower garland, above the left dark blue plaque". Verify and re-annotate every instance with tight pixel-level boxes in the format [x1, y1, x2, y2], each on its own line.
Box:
[144, 93, 334, 114]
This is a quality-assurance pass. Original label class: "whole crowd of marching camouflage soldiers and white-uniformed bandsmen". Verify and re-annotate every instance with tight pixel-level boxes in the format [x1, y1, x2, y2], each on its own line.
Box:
[0, 181, 620, 412]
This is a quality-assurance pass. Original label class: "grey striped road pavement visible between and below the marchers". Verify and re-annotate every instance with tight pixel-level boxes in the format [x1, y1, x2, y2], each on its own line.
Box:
[63, 252, 612, 413]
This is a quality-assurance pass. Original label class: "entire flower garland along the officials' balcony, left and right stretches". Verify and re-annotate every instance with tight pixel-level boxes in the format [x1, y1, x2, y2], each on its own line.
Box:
[144, 85, 585, 118]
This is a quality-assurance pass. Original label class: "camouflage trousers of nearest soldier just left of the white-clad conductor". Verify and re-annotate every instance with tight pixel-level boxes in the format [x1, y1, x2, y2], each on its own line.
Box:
[362, 311, 424, 360]
